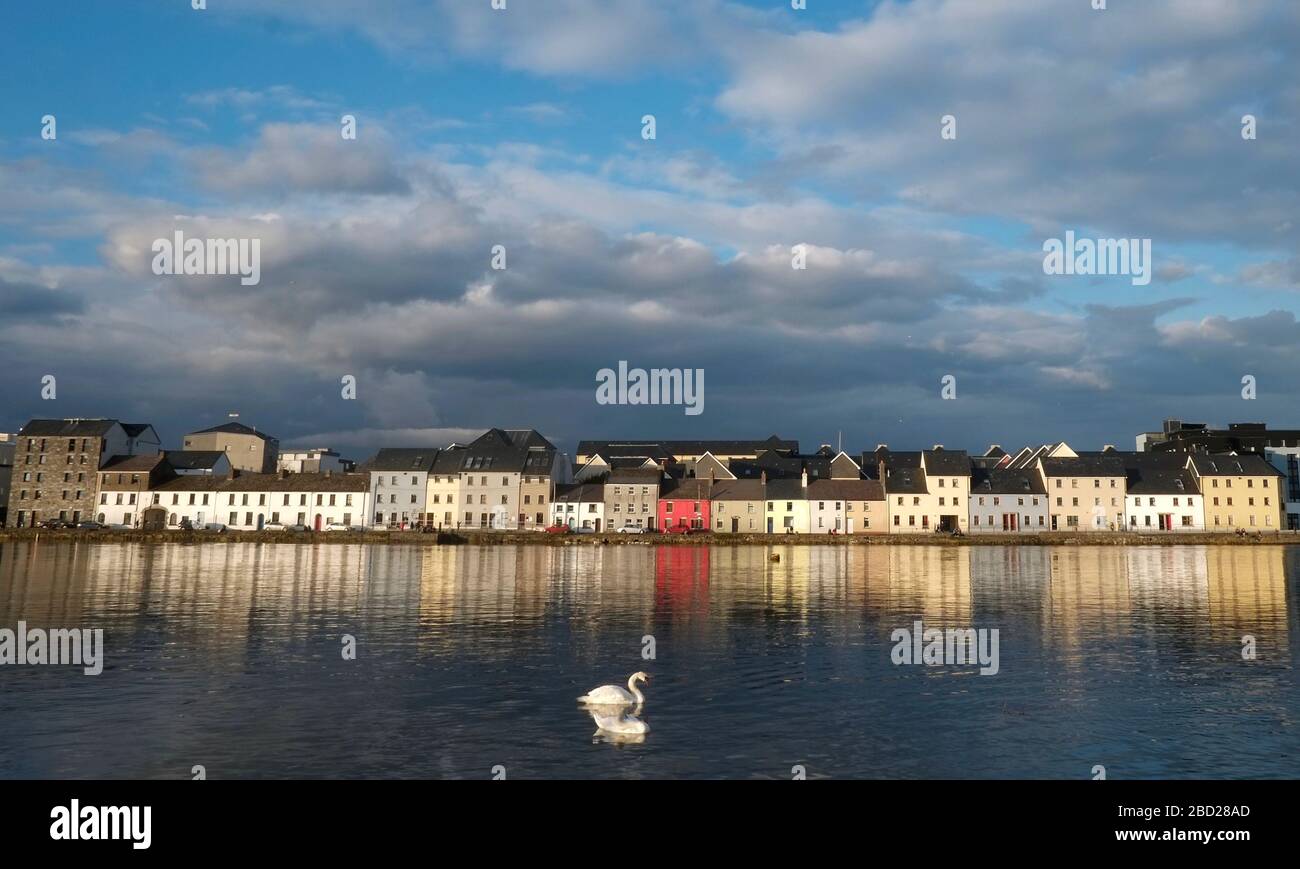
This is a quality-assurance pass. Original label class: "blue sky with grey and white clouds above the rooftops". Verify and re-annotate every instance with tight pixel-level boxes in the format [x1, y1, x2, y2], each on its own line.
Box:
[0, 0, 1300, 459]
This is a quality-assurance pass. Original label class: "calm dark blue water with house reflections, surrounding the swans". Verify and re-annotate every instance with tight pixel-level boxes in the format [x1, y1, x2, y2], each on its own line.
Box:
[0, 544, 1300, 779]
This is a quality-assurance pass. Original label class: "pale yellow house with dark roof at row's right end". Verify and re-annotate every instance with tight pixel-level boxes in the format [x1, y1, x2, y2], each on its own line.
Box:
[1187, 454, 1286, 531]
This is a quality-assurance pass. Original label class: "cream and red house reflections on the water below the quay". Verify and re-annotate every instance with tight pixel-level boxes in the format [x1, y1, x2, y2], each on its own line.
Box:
[0, 541, 1300, 660]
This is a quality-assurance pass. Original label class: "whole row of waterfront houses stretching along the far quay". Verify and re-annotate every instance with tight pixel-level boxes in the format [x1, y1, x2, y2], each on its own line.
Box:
[0, 419, 1300, 535]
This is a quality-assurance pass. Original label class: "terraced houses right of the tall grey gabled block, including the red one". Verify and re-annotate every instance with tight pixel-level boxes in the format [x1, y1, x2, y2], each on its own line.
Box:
[551, 438, 1288, 535]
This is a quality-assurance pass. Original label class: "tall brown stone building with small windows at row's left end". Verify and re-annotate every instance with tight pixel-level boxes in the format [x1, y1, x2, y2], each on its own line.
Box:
[7, 419, 161, 528]
